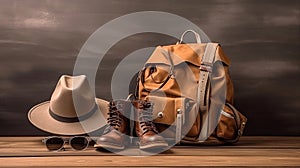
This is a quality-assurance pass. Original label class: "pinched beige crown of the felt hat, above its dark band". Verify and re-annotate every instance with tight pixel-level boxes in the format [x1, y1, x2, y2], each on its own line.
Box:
[49, 75, 96, 118]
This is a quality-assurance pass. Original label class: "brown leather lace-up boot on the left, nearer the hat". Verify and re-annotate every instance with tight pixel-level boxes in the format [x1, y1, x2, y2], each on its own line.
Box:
[94, 100, 132, 150]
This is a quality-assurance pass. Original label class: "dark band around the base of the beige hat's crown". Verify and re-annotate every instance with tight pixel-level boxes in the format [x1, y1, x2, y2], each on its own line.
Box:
[49, 104, 98, 123]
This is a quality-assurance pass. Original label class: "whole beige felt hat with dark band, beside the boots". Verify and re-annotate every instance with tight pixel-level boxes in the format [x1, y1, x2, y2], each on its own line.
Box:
[28, 75, 108, 135]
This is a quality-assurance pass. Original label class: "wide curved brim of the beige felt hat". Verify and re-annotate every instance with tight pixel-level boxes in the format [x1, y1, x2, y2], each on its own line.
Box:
[28, 99, 108, 135]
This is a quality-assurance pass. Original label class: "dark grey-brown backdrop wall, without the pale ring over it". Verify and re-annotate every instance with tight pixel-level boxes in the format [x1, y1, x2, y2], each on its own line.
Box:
[0, 0, 300, 136]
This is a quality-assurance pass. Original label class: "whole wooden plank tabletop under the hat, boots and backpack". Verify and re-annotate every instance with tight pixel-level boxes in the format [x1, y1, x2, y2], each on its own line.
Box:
[0, 136, 300, 167]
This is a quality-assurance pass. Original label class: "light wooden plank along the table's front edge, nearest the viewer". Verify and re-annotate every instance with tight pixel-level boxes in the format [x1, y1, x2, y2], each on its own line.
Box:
[0, 156, 300, 167]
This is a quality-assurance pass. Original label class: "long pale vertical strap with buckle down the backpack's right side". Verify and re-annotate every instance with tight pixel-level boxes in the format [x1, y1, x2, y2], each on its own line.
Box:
[197, 43, 219, 141]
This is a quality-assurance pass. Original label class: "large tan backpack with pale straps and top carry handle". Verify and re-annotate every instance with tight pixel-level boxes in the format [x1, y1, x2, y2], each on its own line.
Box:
[136, 30, 247, 144]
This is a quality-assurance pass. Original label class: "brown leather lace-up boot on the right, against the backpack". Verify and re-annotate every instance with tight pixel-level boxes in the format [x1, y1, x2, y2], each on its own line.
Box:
[133, 100, 168, 149]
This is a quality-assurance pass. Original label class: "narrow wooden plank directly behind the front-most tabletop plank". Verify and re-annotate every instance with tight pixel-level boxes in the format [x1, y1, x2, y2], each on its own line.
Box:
[0, 148, 300, 158]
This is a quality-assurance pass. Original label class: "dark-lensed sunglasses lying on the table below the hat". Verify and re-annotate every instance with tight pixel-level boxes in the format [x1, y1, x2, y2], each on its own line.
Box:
[42, 136, 90, 151]
